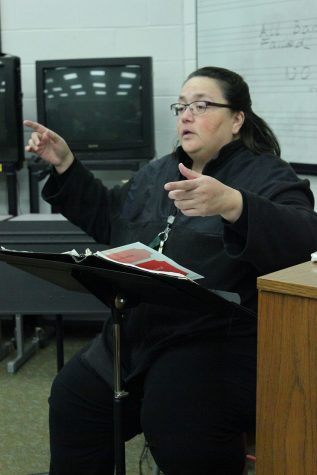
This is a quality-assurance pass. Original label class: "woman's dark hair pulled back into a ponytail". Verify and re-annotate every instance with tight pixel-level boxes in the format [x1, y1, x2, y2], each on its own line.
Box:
[185, 66, 281, 156]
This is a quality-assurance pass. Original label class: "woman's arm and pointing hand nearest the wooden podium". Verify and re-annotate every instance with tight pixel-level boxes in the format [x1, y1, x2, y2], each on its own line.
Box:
[165, 164, 317, 274]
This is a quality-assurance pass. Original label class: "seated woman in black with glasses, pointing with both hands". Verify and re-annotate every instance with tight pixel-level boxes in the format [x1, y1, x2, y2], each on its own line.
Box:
[25, 67, 317, 475]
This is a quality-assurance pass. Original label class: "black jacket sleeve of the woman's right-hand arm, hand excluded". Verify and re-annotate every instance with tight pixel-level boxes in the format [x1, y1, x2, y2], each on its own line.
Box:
[224, 181, 317, 274]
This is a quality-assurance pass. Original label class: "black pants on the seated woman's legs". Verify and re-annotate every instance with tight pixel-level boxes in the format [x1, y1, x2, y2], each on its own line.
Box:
[50, 337, 256, 475]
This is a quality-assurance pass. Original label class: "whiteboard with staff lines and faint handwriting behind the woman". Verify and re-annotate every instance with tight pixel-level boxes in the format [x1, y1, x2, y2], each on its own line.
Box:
[196, 0, 317, 174]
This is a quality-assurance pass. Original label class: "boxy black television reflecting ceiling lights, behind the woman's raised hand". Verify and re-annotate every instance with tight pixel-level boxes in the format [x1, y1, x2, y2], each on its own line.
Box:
[36, 57, 154, 165]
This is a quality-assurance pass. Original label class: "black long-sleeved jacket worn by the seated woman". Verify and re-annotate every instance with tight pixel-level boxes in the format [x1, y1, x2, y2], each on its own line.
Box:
[43, 140, 317, 379]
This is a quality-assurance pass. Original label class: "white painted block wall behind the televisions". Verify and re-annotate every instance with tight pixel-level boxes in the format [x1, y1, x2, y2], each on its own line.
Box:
[0, 0, 196, 214]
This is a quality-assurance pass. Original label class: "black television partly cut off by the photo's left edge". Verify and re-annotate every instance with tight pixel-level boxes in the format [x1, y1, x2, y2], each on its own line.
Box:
[0, 54, 24, 170]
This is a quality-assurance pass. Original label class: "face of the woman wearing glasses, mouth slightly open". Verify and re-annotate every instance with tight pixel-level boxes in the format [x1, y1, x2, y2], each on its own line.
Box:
[177, 76, 244, 163]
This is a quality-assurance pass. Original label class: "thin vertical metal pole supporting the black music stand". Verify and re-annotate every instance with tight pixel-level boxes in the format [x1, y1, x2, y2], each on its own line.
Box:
[112, 296, 128, 475]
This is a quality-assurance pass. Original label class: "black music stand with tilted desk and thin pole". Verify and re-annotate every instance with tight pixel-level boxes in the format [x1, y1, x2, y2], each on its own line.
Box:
[0, 250, 238, 475]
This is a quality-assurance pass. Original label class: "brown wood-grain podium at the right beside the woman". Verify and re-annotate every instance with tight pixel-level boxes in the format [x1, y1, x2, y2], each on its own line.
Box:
[256, 262, 317, 475]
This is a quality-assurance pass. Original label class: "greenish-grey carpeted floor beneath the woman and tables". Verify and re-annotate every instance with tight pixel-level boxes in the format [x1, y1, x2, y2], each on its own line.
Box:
[0, 322, 254, 475]
